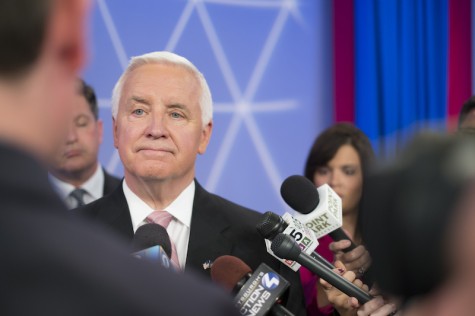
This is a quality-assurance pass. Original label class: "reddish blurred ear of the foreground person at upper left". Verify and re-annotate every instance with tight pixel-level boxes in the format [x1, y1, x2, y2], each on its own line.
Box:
[45, 0, 90, 74]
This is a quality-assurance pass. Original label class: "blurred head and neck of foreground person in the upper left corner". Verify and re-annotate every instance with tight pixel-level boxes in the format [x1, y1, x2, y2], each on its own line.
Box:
[0, 0, 89, 159]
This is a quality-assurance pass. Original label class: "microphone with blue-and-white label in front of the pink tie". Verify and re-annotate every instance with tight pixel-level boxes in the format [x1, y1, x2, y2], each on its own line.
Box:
[132, 223, 176, 270]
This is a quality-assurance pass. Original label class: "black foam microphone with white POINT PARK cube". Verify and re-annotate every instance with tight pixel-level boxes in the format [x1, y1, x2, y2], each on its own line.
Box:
[280, 175, 356, 252]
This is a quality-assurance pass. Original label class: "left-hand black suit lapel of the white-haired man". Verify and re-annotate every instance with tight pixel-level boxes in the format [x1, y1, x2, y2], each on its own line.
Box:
[97, 185, 134, 240]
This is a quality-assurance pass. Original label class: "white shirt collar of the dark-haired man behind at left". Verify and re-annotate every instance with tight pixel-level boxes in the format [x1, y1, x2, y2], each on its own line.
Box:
[49, 165, 104, 199]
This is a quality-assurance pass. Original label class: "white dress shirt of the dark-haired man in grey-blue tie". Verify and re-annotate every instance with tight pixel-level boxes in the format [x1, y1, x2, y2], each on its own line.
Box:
[49, 164, 104, 209]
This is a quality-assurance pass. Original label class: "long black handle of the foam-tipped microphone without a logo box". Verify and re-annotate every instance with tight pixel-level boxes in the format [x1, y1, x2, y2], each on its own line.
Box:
[297, 252, 373, 305]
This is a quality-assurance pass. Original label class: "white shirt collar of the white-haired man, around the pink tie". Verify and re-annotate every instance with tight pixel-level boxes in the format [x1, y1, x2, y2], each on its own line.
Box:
[122, 180, 195, 231]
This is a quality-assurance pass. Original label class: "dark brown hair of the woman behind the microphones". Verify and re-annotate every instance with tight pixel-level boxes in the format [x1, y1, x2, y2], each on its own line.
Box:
[305, 123, 375, 182]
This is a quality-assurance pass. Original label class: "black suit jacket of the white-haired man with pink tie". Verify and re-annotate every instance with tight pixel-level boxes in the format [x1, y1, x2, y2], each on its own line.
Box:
[73, 181, 306, 315]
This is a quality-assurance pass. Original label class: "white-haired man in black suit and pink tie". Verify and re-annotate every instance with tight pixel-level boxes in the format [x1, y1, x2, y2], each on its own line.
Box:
[77, 52, 305, 315]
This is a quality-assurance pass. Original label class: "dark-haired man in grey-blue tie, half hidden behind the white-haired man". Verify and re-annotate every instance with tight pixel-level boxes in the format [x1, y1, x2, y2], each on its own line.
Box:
[49, 79, 120, 209]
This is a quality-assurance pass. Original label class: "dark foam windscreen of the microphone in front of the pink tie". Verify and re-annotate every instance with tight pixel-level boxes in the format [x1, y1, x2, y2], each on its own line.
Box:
[132, 223, 172, 258]
